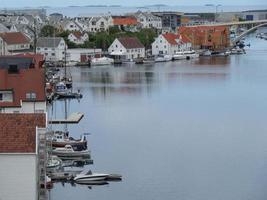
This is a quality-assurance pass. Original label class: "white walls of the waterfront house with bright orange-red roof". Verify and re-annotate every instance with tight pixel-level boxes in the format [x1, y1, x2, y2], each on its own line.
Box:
[152, 34, 192, 55]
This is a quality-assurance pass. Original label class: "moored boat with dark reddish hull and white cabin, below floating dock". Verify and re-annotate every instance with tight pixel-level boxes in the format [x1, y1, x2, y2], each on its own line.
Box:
[52, 131, 87, 151]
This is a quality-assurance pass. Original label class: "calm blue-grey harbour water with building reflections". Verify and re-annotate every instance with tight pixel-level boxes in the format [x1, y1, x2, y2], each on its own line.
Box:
[50, 30, 267, 200]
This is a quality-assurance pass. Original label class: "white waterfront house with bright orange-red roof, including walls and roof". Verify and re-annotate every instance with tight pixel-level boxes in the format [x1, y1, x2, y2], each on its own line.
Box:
[152, 33, 192, 55]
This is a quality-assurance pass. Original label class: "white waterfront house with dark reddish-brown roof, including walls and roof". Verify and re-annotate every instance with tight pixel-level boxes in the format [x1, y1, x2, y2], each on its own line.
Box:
[108, 37, 145, 60]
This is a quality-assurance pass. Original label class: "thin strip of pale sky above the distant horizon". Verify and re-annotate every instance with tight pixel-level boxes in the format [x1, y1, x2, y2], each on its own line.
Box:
[0, 0, 267, 8]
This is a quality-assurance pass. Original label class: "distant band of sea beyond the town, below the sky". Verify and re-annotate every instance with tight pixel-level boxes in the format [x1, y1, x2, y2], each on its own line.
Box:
[47, 3, 267, 17]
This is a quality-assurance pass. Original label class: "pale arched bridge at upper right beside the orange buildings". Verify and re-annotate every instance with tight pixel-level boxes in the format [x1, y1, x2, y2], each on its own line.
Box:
[187, 20, 267, 47]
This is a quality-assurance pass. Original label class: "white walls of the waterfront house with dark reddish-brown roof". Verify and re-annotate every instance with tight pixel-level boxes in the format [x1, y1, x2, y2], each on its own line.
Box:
[108, 39, 145, 60]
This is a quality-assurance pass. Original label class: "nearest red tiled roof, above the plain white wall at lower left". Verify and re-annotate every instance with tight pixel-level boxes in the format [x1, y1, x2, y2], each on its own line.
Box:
[0, 113, 46, 153]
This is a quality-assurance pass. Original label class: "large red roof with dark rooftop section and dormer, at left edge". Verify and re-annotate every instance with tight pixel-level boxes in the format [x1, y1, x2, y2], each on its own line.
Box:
[0, 54, 46, 107]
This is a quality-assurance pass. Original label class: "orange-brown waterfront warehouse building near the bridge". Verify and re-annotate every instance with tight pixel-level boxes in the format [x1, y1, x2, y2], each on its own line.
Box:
[178, 26, 230, 50]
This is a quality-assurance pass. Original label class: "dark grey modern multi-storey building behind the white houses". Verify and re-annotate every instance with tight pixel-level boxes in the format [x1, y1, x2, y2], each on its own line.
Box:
[152, 12, 184, 32]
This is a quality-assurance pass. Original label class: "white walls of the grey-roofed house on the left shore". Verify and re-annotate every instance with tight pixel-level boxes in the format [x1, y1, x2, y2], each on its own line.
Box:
[37, 38, 67, 61]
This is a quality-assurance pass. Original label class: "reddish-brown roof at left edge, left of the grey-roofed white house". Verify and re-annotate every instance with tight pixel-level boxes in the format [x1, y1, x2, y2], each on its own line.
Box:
[0, 32, 30, 45]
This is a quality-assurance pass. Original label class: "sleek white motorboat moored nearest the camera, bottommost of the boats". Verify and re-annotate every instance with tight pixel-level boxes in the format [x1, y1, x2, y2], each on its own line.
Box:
[73, 170, 109, 184]
